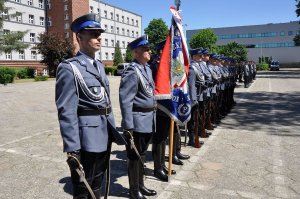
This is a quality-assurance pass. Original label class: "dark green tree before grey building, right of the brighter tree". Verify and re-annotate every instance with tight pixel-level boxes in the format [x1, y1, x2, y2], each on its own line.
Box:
[218, 42, 247, 61]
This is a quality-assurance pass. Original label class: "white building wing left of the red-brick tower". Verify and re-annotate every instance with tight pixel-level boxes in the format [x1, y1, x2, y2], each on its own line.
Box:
[0, 0, 48, 75]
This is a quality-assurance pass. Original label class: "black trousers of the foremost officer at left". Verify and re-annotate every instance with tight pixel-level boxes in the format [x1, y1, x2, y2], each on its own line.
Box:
[71, 151, 109, 199]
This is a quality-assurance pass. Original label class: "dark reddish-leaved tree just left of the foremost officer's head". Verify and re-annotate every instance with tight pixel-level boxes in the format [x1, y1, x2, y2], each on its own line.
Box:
[36, 33, 74, 76]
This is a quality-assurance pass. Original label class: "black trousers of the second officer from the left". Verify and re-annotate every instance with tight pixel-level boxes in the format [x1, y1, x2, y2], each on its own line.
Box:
[126, 132, 153, 160]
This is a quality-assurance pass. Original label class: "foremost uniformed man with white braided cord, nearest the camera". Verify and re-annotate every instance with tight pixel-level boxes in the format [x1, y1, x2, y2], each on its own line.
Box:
[55, 14, 124, 199]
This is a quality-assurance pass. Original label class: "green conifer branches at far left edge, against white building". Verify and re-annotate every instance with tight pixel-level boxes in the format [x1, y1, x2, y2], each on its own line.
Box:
[0, 0, 29, 53]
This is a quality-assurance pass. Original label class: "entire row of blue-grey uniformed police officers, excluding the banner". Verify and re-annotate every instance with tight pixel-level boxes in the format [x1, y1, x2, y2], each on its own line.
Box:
[55, 14, 253, 199]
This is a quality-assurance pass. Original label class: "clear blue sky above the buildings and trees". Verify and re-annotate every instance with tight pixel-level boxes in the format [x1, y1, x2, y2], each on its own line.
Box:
[102, 0, 300, 30]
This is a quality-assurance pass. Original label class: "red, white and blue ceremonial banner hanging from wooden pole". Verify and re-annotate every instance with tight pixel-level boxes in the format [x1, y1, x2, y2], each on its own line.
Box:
[155, 7, 191, 125]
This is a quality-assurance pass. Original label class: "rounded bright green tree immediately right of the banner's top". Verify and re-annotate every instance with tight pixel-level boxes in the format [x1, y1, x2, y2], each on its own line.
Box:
[189, 29, 217, 51]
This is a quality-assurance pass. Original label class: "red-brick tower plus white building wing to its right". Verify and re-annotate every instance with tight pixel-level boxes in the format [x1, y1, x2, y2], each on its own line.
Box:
[47, 0, 142, 66]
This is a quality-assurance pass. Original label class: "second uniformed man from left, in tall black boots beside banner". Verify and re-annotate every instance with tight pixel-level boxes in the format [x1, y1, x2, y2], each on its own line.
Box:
[119, 36, 156, 199]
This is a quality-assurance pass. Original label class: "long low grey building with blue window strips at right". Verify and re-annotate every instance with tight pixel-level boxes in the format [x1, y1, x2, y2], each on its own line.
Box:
[187, 21, 300, 63]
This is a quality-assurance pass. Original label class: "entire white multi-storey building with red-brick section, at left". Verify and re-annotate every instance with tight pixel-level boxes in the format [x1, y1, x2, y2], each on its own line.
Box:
[0, 0, 142, 75]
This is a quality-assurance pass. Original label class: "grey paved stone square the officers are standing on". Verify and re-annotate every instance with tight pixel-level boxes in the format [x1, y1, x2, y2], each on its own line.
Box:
[0, 69, 300, 199]
